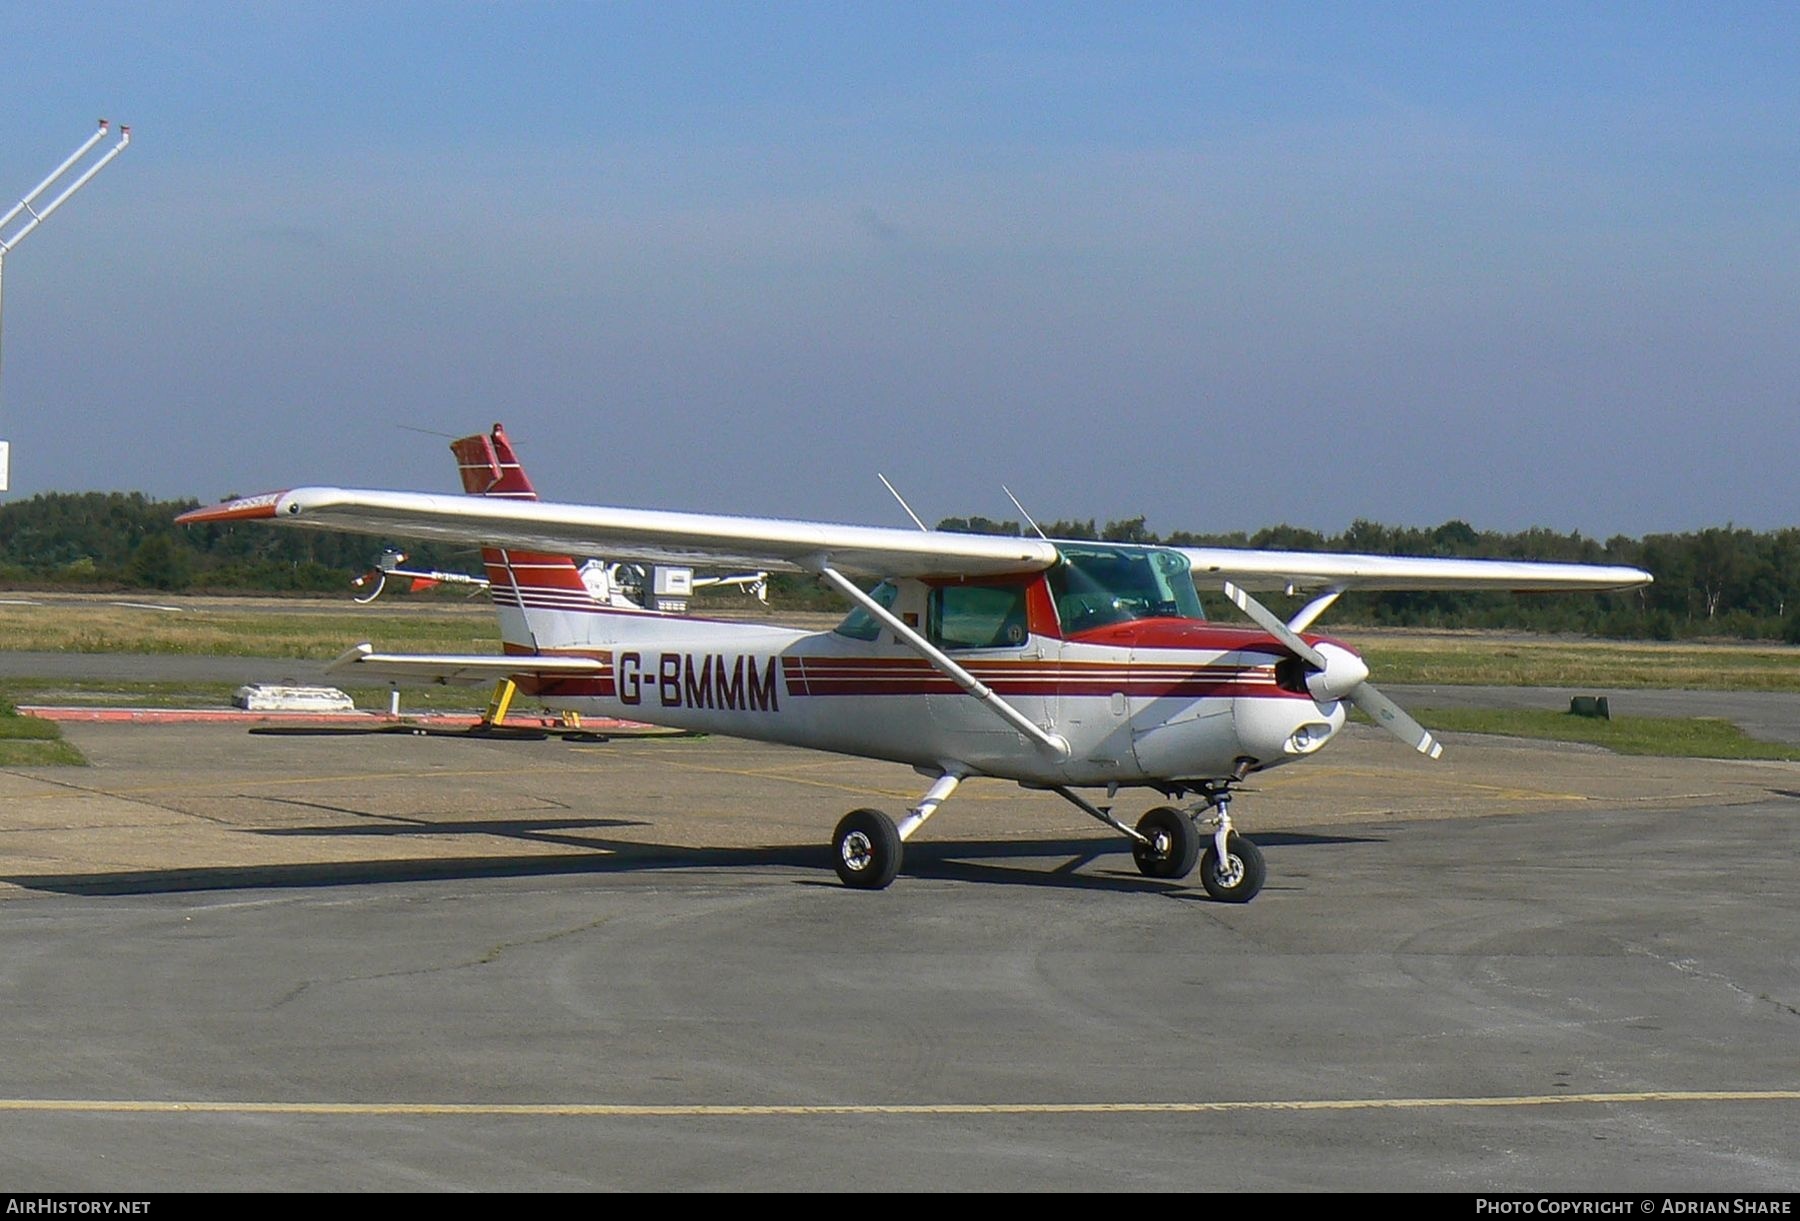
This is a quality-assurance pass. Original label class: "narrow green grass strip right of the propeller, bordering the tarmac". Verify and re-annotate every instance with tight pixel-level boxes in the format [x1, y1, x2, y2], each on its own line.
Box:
[1413, 708, 1800, 762]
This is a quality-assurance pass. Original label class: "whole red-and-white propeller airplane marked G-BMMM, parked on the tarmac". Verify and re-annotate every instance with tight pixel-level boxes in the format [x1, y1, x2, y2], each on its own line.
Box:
[178, 425, 1651, 902]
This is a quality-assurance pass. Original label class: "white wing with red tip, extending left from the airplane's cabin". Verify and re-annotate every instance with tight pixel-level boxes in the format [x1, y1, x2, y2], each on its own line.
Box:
[176, 488, 1057, 576]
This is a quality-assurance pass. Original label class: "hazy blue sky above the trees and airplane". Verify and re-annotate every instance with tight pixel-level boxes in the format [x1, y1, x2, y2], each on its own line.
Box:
[0, 4, 1800, 537]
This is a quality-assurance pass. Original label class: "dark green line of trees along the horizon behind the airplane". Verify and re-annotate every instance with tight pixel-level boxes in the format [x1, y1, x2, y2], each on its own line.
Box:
[0, 492, 1800, 643]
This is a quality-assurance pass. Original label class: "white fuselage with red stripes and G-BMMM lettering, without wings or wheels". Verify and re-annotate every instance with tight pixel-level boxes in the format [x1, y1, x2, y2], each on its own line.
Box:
[490, 544, 1345, 785]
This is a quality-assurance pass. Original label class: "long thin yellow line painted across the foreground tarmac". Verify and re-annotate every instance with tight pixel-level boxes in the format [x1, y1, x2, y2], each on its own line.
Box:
[0, 1090, 1800, 1118]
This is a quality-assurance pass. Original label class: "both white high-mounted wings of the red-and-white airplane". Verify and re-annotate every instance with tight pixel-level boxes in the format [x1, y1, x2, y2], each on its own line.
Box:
[176, 488, 1651, 591]
